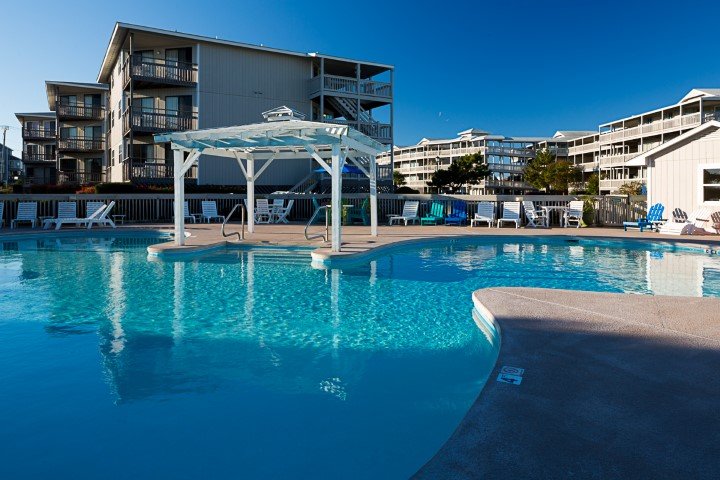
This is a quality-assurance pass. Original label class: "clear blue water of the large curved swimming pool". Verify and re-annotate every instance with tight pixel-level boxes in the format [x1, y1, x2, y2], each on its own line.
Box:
[0, 237, 720, 479]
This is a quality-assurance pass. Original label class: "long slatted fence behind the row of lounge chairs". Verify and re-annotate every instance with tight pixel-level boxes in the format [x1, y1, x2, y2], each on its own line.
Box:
[0, 193, 646, 226]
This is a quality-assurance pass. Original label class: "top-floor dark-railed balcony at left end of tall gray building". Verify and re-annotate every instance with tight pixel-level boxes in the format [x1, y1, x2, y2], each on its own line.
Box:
[122, 55, 197, 88]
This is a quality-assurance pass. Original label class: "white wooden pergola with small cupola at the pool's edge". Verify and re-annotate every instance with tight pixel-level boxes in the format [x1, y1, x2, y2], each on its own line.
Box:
[155, 107, 386, 252]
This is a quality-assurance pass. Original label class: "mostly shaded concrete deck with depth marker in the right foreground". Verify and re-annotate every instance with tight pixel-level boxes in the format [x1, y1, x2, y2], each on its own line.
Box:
[416, 288, 720, 479]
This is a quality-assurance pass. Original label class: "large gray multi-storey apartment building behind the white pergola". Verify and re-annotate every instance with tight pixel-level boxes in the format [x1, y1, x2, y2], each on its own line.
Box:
[18, 23, 393, 189]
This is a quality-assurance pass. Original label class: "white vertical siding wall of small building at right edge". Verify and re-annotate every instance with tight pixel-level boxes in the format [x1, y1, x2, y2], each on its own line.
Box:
[650, 130, 720, 212]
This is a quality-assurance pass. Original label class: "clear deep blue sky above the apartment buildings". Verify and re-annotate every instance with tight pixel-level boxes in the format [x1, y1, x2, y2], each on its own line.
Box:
[0, 0, 720, 151]
